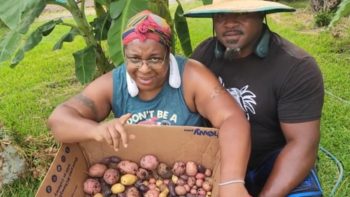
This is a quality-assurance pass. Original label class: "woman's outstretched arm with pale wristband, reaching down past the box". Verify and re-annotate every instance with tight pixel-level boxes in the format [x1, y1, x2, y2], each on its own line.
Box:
[184, 60, 251, 197]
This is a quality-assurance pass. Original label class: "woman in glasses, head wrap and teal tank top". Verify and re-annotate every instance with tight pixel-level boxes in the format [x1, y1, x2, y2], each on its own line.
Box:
[48, 11, 250, 197]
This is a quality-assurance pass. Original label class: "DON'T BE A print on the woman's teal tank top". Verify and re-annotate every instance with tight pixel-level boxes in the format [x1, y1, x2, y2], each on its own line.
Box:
[128, 110, 177, 125]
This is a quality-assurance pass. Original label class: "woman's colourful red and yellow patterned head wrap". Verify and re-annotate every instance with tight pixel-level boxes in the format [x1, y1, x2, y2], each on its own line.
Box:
[122, 10, 171, 48]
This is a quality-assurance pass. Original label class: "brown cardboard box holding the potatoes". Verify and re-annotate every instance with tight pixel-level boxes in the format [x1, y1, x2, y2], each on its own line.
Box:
[36, 125, 219, 197]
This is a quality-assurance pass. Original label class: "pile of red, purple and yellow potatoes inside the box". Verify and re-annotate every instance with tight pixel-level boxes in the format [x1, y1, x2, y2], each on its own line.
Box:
[84, 154, 213, 197]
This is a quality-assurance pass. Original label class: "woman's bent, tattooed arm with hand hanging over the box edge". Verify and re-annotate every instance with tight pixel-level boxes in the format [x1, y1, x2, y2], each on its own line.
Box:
[48, 72, 130, 149]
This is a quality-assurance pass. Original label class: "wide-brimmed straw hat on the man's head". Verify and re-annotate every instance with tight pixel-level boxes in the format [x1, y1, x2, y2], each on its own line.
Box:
[184, 0, 295, 18]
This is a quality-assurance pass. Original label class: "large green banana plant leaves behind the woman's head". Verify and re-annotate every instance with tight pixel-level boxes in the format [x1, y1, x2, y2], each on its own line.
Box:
[0, 0, 205, 84]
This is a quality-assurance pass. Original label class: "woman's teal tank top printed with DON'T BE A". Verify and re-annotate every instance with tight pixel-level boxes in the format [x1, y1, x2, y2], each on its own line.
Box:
[112, 56, 203, 126]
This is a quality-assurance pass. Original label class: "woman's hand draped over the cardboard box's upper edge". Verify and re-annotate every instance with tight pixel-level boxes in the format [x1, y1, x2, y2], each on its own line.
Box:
[95, 114, 131, 151]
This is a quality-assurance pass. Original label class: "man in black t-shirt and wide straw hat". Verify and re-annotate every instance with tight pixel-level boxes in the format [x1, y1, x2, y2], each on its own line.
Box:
[185, 0, 324, 197]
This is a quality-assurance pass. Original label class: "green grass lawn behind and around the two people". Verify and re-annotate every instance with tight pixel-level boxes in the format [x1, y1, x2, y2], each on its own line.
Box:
[0, 1, 350, 197]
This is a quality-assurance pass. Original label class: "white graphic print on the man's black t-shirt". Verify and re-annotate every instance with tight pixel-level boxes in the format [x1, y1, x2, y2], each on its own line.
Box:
[219, 77, 256, 120]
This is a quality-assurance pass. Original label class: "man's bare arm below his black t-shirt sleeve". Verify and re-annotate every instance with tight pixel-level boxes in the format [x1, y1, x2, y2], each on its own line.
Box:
[260, 120, 320, 197]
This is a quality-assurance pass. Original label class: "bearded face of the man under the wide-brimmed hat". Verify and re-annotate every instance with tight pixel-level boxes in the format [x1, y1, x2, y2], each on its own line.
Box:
[213, 13, 264, 58]
